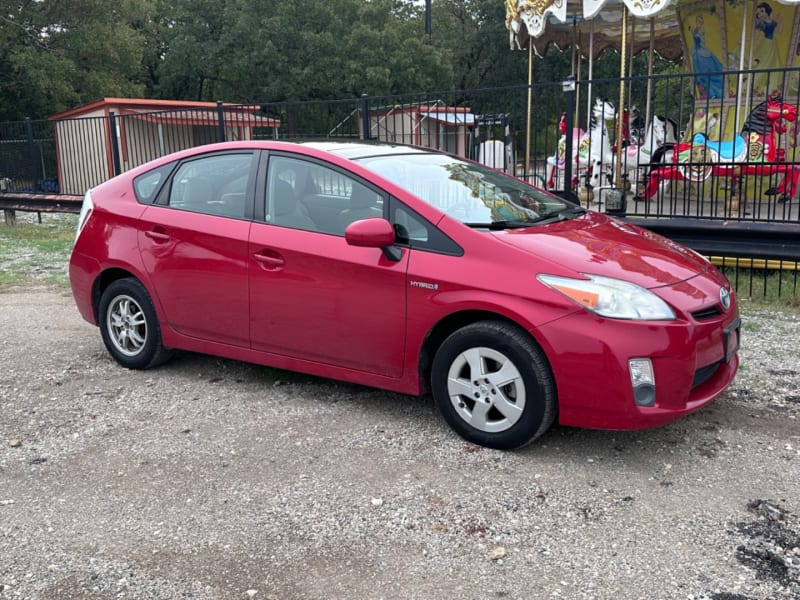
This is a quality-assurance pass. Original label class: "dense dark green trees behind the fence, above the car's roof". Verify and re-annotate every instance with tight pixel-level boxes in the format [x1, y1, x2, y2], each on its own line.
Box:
[153, 0, 453, 102]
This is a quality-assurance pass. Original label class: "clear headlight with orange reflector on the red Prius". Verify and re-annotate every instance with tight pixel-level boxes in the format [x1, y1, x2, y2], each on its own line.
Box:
[537, 275, 675, 321]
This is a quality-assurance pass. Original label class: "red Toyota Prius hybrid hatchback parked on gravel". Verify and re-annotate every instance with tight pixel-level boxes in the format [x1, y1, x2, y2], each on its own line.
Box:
[70, 142, 740, 449]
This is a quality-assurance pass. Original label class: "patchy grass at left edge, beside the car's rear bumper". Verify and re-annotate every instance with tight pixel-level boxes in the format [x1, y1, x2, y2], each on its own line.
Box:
[0, 213, 78, 288]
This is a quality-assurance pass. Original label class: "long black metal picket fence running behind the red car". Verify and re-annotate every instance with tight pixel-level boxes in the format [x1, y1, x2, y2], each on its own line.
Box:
[0, 69, 800, 296]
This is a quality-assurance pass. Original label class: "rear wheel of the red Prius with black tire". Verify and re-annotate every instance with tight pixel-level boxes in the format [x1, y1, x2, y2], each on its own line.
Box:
[99, 278, 171, 369]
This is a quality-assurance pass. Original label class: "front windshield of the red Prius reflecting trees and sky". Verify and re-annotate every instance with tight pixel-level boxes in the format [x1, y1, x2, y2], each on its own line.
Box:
[358, 153, 577, 227]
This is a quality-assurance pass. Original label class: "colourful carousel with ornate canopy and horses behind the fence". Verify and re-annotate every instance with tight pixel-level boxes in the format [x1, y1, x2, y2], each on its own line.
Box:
[506, 0, 800, 214]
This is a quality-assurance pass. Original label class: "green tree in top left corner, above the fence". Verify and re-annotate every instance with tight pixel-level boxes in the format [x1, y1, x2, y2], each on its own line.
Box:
[0, 0, 152, 120]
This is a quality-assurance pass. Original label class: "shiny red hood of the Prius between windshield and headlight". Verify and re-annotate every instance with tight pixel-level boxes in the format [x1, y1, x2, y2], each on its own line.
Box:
[493, 212, 708, 289]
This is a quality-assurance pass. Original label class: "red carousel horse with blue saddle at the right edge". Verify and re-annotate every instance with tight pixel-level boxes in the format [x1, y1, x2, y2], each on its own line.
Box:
[644, 96, 800, 202]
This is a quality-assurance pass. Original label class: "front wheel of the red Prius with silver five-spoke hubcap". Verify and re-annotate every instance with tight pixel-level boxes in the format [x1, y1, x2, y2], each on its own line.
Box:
[431, 321, 557, 450]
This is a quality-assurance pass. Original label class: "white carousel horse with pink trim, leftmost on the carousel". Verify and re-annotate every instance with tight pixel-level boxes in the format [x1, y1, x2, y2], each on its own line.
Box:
[546, 98, 616, 189]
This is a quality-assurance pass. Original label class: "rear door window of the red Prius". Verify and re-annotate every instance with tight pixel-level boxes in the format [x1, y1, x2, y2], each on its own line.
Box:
[167, 153, 253, 219]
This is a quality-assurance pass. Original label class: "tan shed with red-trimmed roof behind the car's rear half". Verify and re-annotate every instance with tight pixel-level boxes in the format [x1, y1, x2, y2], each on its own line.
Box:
[50, 98, 280, 194]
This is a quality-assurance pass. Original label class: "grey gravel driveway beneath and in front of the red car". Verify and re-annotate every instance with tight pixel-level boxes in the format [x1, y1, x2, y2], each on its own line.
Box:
[0, 287, 800, 600]
